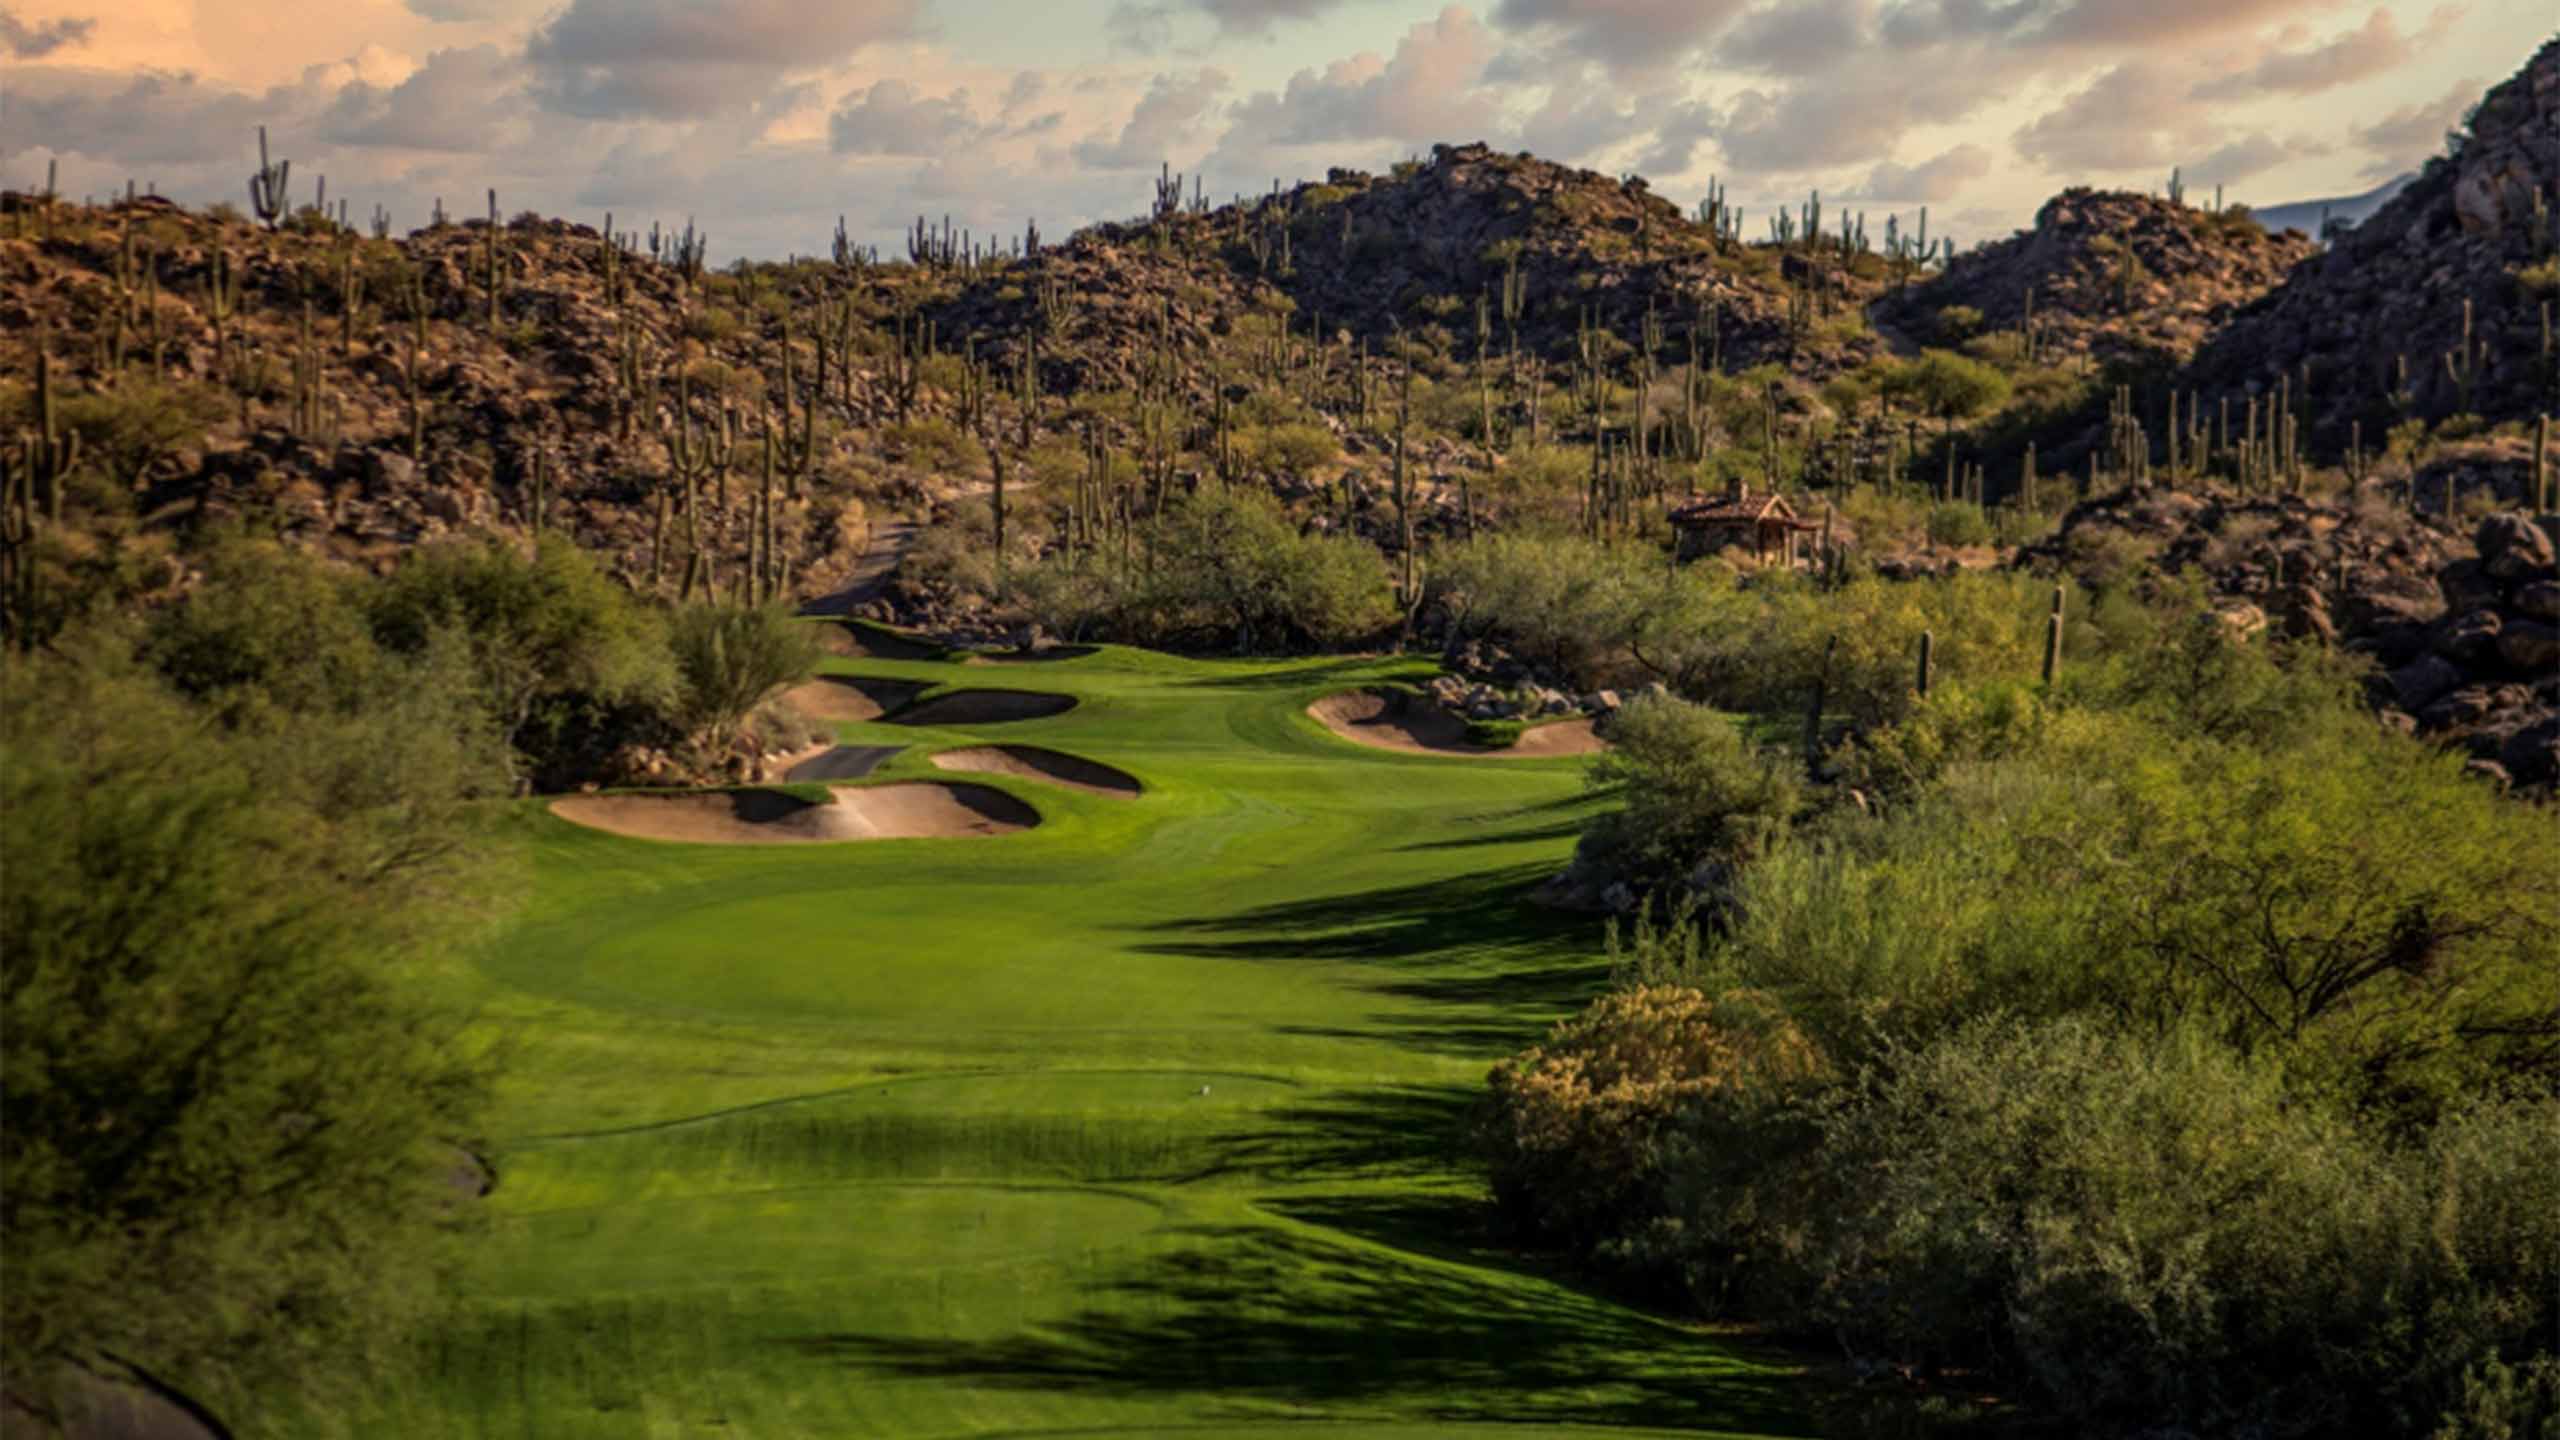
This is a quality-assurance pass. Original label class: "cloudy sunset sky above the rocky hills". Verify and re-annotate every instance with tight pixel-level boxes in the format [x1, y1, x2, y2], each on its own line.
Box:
[0, 0, 2555, 264]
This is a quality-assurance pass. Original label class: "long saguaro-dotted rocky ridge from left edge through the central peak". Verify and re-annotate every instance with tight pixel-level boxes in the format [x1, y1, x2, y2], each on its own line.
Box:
[0, 146, 1917, 632]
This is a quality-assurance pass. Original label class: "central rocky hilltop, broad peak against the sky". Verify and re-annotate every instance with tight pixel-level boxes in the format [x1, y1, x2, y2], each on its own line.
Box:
[929, 143, 1889, 397]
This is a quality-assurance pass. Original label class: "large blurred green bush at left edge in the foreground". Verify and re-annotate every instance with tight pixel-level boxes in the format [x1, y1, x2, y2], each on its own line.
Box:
[0, 635, 504, 1402]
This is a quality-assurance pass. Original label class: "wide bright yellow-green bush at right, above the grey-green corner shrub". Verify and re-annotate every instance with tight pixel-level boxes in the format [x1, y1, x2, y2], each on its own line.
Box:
[1710, 712, 2560, 1120]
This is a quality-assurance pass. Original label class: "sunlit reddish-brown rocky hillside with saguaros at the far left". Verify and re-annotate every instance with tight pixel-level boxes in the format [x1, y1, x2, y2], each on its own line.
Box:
[0, 195, 914, 592]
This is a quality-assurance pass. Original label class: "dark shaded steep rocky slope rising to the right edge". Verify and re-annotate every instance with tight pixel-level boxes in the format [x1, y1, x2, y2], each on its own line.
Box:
[2191, 38, 2560, 454]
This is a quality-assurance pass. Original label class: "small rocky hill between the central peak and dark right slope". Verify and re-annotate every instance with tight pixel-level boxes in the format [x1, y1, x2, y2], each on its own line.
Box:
[1879, 187, 2317, 369]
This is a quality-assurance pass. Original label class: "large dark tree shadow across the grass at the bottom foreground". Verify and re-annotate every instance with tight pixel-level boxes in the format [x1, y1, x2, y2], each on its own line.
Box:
[783, 1202, 1805, 1435]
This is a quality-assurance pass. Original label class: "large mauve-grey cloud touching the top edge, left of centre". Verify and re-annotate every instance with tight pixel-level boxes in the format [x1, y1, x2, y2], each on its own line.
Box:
[525, 0, 922, 120]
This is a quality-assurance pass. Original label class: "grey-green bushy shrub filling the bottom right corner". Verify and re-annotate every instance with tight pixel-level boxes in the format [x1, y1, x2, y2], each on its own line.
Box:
[1761, 1017, 2560, 1435]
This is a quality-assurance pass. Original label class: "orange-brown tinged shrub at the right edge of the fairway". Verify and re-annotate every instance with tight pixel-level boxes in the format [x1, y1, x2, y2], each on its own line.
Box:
[1480, 986, 1818, 1250]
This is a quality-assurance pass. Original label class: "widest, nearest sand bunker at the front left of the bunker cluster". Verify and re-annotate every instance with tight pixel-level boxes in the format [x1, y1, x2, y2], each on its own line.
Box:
[550, 781, 1039, 846]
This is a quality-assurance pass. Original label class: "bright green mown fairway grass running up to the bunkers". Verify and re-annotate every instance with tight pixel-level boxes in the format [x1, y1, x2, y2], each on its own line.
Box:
[290, 648, 1805, 1440]
